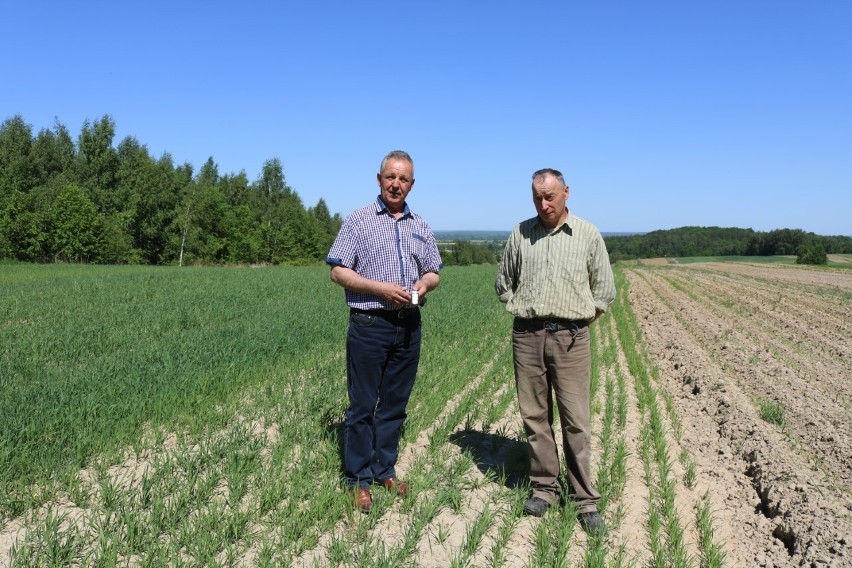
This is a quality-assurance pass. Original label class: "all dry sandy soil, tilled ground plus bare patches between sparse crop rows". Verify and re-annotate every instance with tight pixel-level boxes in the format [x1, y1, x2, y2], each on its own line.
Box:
[0, 261, 852, 568]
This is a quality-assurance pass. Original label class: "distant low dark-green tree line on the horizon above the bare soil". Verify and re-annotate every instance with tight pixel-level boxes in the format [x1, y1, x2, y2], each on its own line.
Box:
[604, 227, 852, 264]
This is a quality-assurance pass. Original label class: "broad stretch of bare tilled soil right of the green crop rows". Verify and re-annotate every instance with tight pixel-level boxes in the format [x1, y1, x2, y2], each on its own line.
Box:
[627, 263, 852, 566]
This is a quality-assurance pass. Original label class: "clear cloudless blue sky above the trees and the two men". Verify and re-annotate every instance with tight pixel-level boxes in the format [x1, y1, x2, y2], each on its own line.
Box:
[0, 0, 852, 235]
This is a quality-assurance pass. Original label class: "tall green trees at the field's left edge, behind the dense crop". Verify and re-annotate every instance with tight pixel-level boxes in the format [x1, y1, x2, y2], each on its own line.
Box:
[0, 115, 342, 265]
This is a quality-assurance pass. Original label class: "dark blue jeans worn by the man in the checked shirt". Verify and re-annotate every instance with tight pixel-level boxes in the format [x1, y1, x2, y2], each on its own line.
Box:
[343, 310, 420, 488]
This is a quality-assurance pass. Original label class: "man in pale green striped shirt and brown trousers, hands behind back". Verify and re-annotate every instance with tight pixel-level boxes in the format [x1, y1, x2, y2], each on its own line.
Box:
[495, 168, 615, 532]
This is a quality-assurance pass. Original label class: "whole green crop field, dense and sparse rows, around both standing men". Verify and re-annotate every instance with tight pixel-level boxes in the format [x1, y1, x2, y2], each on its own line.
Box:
[0, 264, 718, 567]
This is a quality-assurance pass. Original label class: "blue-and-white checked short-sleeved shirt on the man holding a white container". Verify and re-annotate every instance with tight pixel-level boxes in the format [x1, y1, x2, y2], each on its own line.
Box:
[326, 196, 443, 310]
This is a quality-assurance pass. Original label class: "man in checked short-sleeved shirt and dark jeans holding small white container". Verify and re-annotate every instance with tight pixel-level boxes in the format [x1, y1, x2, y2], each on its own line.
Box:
[326, 150, 442, 512]
